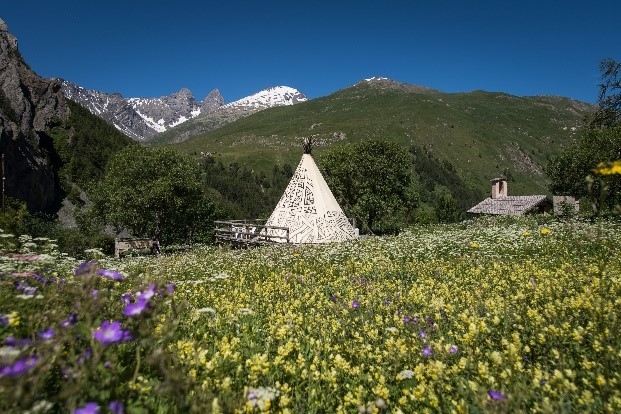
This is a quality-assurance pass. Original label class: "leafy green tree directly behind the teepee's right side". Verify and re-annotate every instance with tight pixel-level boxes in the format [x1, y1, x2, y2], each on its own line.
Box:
[321, 139, 417, 234]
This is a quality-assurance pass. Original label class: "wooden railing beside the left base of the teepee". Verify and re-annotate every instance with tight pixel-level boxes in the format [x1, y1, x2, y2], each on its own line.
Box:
[214, 220, 289, 246]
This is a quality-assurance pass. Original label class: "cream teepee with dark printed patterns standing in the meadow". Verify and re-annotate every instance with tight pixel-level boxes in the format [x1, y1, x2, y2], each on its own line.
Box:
[265, 138, 357, 243]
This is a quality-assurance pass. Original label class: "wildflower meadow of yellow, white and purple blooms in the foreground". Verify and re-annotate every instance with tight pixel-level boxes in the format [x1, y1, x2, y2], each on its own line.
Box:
[0, 216, 621, 414]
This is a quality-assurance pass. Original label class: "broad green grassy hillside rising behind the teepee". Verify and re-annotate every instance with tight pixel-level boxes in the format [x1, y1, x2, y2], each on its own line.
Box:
[163, 80, 593, 195]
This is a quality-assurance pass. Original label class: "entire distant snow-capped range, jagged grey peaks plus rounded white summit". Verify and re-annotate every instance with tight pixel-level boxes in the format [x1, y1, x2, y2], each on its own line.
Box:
[62, 80, 307, 141]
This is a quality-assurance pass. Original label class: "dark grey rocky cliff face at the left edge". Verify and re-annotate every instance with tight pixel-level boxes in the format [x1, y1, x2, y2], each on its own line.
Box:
[0, 19, 69, 211]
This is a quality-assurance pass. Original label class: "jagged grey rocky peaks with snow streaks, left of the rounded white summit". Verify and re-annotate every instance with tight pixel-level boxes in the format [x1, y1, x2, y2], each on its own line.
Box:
[60, 80, 224, 141]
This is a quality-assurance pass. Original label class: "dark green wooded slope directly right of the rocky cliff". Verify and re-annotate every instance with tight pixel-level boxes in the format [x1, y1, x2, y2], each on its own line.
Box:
[49, 100, 138, 191]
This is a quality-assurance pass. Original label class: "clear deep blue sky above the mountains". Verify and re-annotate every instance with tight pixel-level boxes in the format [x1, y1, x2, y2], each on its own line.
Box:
[0, 0, 621, 102]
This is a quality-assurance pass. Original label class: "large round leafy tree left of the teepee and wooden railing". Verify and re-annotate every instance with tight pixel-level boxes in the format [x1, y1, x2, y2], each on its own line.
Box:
[93, 146, 216, 243]
